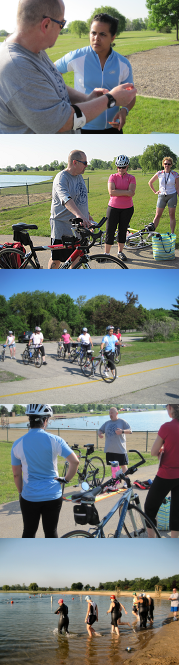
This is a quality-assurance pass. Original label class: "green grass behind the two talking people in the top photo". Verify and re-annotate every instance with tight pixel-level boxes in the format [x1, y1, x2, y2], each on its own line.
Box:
[0, 30, 179, 134]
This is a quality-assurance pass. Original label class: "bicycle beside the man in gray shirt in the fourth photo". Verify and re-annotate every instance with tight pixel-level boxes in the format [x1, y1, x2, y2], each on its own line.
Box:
[63, 443, 105, 489]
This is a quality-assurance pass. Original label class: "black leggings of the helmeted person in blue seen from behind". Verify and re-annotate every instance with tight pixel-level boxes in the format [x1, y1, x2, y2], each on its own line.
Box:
[20, 496, 62, 538]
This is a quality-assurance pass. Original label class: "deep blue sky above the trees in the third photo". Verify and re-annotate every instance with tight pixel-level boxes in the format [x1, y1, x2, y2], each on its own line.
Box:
[0, 270, 179, 309]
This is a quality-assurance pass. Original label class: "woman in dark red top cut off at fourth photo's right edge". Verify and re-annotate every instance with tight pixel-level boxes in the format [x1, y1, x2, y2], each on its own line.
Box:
[144, 404, 179, 538]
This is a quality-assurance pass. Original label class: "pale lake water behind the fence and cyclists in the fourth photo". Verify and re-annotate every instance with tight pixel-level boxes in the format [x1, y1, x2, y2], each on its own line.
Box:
[10, 409, 170, 432]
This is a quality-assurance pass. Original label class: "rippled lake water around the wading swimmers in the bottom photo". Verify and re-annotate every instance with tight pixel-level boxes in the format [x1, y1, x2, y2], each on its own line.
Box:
[0, 592, 170, 665]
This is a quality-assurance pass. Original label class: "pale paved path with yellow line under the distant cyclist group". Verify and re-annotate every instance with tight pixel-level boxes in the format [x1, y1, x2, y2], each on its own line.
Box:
[0, 336, 179, 404]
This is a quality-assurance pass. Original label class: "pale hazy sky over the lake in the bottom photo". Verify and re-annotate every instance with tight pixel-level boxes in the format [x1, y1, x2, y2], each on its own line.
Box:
[0, 538, 178, 587]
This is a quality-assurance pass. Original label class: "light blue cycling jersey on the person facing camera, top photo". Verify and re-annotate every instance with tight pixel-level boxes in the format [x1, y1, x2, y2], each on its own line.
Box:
[55, 46, 133, 130]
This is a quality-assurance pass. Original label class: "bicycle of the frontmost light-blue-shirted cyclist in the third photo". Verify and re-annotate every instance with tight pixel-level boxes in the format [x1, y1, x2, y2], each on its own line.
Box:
[81, 351, 117, 383]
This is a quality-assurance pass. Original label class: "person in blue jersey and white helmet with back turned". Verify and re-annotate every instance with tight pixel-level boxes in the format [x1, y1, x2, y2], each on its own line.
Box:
[11, 404, 79, 538]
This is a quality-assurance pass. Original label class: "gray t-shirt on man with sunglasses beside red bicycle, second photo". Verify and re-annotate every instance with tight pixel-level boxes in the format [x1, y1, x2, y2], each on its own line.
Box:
[50, 170, 88, 240]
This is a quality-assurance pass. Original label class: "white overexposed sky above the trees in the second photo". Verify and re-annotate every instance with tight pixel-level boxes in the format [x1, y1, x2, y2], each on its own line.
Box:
[0, 134, 179, 168]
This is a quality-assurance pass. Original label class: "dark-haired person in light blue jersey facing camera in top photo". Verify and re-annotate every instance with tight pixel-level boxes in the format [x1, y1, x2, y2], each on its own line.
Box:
[55, 13, 135, 134]
